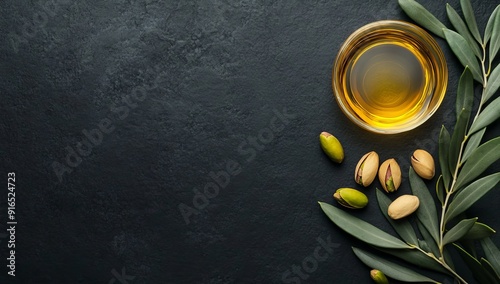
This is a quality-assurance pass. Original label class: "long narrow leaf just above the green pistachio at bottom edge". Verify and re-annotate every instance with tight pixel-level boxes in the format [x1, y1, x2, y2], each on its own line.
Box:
[352, 247, 439, 283]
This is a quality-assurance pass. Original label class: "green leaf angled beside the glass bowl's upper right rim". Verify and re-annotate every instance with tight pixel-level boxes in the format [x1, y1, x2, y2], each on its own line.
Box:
[443, 29, 483, 83]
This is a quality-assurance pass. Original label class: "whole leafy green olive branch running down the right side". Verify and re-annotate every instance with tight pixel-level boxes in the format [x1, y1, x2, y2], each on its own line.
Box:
[319, 0, 500, 283]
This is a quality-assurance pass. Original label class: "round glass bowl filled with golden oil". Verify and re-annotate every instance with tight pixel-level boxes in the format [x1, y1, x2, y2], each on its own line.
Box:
[332, 21, 448, 134]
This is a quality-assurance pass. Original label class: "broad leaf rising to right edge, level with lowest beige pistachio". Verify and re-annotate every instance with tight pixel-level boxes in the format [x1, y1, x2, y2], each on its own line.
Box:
[445, 172, 500, 222]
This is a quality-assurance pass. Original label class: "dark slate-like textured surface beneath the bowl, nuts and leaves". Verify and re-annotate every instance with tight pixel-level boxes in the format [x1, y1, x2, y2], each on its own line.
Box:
[0, 0, 500, 284]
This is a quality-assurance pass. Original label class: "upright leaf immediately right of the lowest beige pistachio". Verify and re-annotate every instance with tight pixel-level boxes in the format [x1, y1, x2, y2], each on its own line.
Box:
[410, 167, 439, 243]
